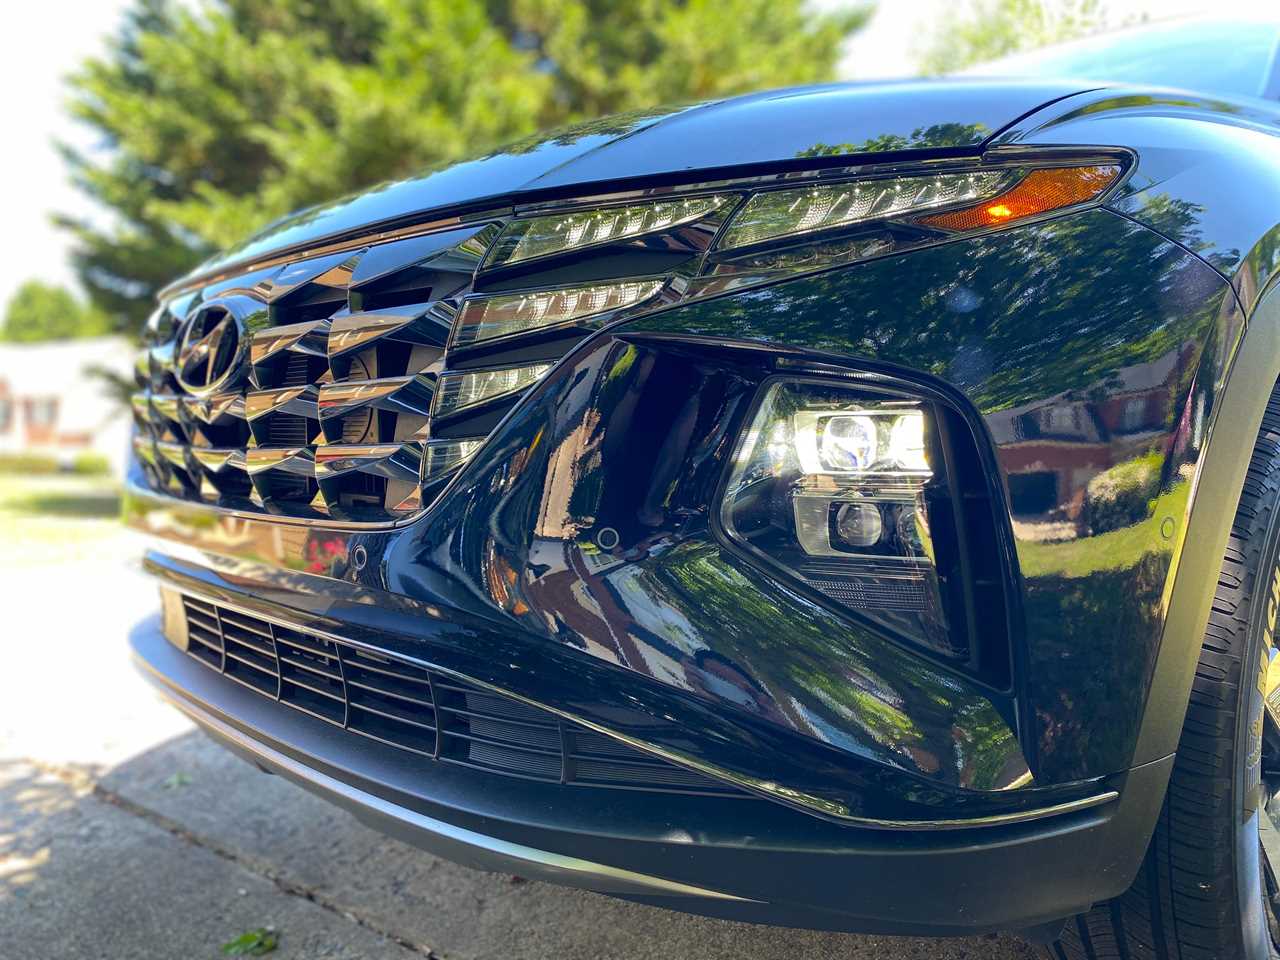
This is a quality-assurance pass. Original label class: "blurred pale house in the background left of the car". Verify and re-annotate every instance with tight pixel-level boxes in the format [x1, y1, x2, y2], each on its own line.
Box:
[0, 337, 136, 474]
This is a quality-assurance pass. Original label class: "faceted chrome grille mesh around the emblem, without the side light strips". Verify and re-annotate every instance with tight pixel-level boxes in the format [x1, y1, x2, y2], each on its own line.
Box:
[131, 224, 483, 522]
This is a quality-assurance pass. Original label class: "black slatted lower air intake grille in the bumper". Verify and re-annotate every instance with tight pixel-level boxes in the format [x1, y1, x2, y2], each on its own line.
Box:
[183, 596, 746, 796]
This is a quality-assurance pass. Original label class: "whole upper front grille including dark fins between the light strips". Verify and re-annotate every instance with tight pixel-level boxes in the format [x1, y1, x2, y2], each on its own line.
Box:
[133, 195, 727, 524]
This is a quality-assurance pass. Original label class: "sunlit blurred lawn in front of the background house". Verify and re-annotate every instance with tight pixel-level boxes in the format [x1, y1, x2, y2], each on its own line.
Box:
[0, 474, 128, 568]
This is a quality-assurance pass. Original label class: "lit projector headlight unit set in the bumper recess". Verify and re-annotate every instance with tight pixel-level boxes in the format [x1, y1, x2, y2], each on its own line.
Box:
[721, 380, 966, 655]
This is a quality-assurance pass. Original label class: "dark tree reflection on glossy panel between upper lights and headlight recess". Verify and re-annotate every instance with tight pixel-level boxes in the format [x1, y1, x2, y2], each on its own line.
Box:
[646, 210, 1220, 412]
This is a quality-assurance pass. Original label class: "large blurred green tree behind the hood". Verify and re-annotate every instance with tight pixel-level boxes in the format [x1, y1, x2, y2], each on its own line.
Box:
[63, 0, 869, 329]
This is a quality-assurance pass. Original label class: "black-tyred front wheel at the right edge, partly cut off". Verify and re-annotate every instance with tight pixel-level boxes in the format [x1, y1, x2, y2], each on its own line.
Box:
[1047, 388, 1280, 960]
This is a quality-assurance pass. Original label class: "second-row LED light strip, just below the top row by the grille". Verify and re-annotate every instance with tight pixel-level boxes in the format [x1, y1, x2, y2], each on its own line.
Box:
[451, 278, 666, 347]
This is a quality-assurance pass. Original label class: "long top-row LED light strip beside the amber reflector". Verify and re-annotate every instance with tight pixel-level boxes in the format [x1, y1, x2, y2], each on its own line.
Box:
[719, 170, 1020, 250]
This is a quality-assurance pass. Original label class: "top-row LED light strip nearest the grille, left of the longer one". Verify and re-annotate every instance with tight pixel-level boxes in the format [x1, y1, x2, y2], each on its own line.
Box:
[488, 195, 733, 266]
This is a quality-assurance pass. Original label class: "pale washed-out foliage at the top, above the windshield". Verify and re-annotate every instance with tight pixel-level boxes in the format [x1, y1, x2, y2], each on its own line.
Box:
[919, 0, 1106, 76]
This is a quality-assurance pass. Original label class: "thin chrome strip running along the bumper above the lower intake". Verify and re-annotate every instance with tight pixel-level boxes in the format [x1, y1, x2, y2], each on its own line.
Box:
[146, 570, 1120, 832]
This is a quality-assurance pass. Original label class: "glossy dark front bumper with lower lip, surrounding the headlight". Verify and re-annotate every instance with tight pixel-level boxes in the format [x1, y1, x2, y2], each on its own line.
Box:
[127, 200, 1230, 934]
